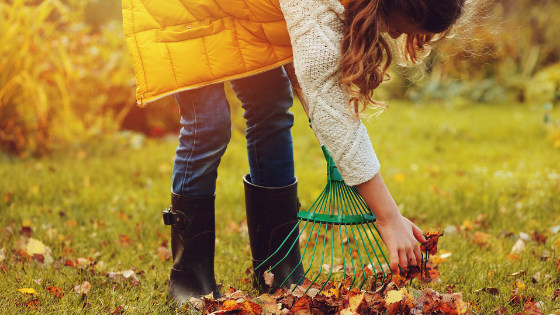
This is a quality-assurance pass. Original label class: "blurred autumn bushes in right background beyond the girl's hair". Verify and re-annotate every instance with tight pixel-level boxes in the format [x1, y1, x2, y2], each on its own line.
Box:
[384, 0, 560, 105]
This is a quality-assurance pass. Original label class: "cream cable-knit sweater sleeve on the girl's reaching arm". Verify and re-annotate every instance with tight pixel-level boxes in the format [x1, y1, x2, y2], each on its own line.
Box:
[280, 0, 380, 186]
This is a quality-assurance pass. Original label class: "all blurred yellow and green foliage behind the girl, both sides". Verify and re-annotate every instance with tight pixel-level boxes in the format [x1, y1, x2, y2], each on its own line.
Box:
[0, 0, 560, 157]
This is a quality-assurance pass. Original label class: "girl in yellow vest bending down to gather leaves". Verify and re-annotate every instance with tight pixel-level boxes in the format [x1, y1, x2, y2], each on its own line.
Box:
[123, 0, 465, 303]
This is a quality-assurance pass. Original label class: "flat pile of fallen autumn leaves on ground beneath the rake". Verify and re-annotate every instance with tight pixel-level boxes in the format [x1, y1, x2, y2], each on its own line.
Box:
[195, 282, 467, 315]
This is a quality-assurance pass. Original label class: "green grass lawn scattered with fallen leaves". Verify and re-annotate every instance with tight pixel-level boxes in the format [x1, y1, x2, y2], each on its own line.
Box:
[0, 102, 560, 314]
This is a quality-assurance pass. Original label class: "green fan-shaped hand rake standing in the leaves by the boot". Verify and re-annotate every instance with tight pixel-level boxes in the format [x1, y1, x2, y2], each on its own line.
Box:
[256, 64, 393, 290]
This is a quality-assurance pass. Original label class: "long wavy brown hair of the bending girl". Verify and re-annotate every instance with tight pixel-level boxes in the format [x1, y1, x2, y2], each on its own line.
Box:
[339, 0, 466, 116]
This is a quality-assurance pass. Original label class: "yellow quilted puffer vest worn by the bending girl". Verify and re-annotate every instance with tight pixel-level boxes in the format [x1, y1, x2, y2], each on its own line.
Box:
[122, 0, 292, 106]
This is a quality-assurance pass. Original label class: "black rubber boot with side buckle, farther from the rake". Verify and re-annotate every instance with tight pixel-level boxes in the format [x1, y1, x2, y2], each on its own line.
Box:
[163, 193, 221, 305]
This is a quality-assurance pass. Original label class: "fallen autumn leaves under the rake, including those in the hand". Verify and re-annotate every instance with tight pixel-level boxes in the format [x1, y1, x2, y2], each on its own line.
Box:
[184, 232, 467, 315]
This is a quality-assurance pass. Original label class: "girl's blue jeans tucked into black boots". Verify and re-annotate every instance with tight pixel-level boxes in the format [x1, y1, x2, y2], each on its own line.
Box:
[172, 67, 295, 197]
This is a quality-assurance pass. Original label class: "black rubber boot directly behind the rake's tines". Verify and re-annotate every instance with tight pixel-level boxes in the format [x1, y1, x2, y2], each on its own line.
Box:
[243, 174, 304, 292]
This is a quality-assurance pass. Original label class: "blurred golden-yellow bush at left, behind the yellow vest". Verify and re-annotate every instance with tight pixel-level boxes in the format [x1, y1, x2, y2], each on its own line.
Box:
[0, 0, 141, 155]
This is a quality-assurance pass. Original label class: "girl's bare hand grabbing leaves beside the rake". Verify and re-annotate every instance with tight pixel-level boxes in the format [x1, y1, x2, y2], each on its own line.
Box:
[376, 213, 426, 273]
